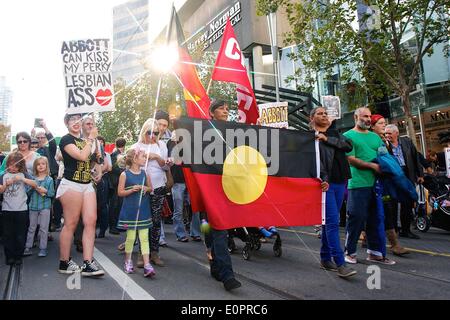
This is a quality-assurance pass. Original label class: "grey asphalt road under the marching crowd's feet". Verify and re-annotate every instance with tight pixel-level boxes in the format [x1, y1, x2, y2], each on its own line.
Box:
[0, 224, 450, 301]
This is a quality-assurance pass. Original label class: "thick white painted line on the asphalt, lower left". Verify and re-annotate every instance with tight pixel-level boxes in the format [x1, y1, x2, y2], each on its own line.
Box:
[94, 247, 155, 300]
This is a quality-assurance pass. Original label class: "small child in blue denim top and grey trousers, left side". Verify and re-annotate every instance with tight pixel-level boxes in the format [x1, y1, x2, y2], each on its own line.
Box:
[23, 157, 55, 257]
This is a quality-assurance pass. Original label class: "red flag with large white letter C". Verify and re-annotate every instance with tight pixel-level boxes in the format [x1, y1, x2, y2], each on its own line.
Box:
[211, 19, 259, 124]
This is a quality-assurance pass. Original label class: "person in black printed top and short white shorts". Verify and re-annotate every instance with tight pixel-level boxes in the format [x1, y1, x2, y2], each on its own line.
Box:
[56, 114, 105, 277]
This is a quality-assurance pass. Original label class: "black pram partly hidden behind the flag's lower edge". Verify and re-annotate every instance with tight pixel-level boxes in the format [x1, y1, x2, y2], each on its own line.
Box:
[228, 227, 283, 260]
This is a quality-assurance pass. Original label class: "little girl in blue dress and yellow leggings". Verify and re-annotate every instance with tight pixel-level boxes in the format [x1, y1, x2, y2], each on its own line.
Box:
[117, 149, 155, 277]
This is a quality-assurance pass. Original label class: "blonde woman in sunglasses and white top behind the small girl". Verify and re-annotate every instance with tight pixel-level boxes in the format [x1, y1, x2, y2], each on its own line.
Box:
[132, 118, 173, 267]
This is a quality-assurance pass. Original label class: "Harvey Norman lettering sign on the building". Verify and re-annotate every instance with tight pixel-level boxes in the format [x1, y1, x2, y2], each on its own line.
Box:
[188, 1, 242, 52]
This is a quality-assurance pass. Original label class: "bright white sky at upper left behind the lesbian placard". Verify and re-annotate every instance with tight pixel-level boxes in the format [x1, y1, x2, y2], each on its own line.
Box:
[0, 0, 178, 136]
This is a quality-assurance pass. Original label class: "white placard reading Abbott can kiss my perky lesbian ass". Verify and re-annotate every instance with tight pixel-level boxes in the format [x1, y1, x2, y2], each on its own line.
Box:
[61, 39, 115, 114]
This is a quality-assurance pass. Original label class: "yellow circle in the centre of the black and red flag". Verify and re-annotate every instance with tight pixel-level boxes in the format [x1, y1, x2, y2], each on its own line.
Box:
[222, 146, 267, 204]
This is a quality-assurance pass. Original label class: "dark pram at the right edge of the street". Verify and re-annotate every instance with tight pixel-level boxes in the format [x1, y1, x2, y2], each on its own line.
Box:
[416, 174, 450, 232]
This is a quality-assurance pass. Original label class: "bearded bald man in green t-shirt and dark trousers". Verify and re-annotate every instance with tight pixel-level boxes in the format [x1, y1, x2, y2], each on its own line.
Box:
[344, 107, 395, 264]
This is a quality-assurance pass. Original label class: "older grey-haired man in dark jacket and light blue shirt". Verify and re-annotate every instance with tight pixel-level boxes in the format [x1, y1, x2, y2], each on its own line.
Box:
[385, 124, 423, 239]
